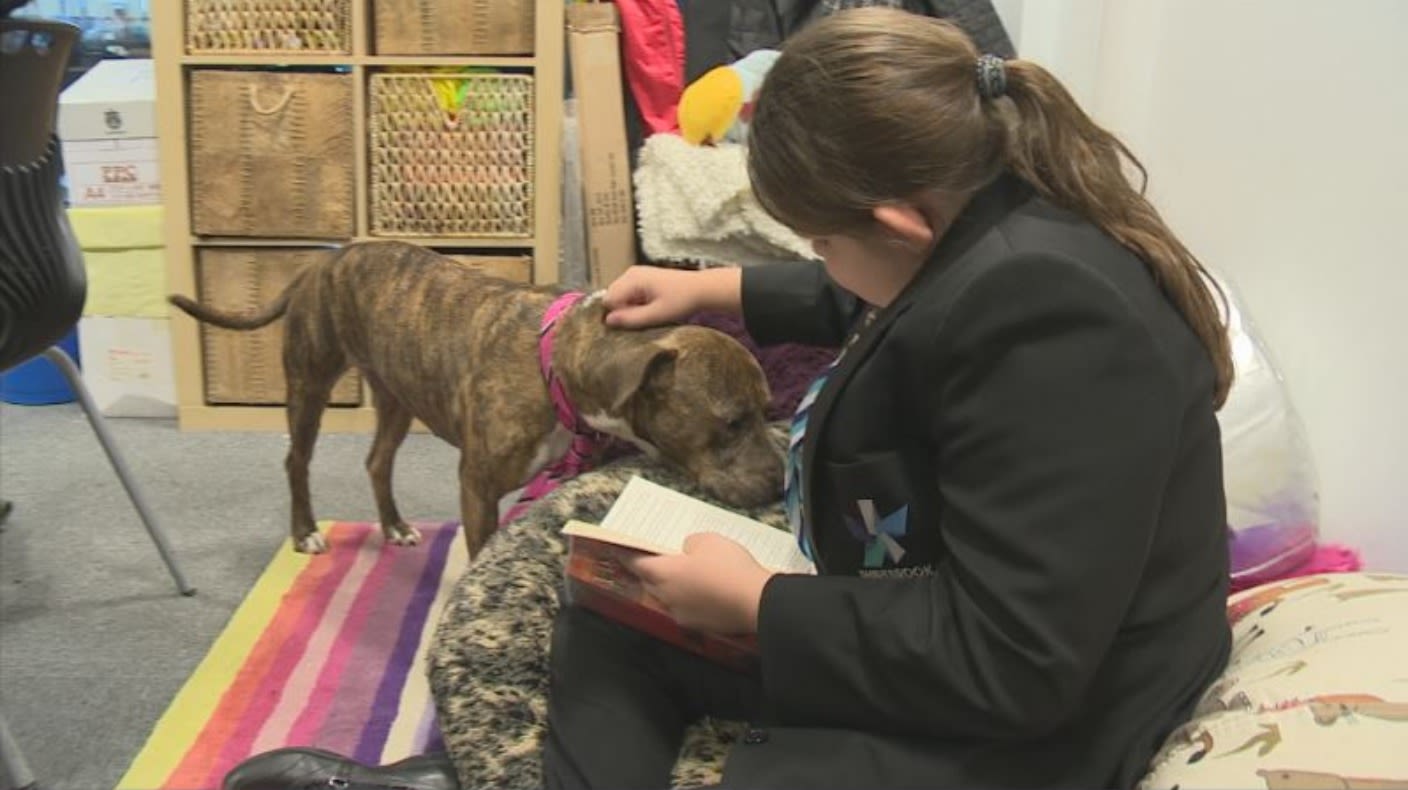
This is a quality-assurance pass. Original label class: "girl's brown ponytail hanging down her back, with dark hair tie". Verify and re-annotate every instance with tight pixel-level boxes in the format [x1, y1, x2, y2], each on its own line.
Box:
[1002, 56, 1233, 408]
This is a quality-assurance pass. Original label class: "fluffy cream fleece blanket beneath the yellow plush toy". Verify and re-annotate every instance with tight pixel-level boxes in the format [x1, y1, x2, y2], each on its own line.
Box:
[635, 134, 817, 266]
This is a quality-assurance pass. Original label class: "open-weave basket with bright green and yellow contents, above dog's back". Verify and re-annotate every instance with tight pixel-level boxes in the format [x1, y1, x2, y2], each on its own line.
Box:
[370, 73, 534, 238]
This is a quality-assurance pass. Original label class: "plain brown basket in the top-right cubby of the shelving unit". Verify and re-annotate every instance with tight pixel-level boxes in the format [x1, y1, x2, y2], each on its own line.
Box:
[372, 0, 534, 55]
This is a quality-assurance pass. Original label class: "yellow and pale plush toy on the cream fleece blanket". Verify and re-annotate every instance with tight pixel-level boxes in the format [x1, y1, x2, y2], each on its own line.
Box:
[676, 49, 780, 145]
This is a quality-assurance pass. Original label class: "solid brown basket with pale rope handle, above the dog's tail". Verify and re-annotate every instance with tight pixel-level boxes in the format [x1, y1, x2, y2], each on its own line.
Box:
[190, 69, 356, 239]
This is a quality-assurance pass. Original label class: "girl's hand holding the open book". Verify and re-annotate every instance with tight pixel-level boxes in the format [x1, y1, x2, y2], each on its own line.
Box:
[624, 532, 773, 634]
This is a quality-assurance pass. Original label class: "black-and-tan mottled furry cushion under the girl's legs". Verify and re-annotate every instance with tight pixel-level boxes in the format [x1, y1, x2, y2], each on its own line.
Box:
[427, 422, 786, 790]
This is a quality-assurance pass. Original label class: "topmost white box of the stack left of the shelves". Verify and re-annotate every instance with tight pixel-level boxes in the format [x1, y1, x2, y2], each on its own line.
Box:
[58, 59, 156, 142]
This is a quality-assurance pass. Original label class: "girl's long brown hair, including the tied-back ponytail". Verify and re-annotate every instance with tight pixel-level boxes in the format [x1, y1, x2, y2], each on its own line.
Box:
[748, 8, 1233, 407]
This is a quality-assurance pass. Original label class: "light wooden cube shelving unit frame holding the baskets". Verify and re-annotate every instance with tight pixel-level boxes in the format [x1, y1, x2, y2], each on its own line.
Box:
[152, 0, 565, 432]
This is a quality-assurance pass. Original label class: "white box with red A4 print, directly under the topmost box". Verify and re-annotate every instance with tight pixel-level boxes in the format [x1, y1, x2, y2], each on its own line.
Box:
[63, 137, 162, 206]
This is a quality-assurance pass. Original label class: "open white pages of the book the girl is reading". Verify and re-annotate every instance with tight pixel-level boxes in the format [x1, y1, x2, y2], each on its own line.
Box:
[577, 477, 814, 573]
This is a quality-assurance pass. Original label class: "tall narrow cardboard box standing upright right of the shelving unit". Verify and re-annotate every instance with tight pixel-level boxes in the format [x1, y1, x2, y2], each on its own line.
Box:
[566, 3, 635, 287]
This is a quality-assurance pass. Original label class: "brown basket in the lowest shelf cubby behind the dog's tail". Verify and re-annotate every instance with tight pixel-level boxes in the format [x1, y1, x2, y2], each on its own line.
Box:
[196, 248, 362, 406]
